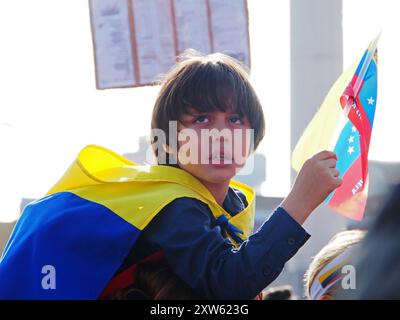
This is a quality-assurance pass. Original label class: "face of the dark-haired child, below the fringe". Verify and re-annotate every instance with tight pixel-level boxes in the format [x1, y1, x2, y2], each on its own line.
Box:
[173, 109, 253, 183]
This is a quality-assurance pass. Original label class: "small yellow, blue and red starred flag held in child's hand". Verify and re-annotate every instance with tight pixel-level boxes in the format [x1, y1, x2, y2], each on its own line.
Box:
[292, 37, 379, 220]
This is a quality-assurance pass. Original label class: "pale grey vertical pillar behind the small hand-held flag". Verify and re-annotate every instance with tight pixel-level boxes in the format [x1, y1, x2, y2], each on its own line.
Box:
[275, 0, 346, 295]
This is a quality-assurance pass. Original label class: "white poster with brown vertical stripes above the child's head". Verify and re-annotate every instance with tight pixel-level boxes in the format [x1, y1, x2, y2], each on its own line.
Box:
[89, 0, 250, 89]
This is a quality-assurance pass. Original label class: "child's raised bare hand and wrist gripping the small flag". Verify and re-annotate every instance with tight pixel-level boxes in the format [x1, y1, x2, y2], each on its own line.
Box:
[281, 151, 342, 224]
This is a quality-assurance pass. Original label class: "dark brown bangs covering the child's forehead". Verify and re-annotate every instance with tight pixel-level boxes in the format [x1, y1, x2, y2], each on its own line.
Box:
[175, 63, 248, 116]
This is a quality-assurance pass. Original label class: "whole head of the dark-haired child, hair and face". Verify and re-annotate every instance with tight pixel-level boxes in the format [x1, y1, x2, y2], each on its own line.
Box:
[151, 51, 265, 183]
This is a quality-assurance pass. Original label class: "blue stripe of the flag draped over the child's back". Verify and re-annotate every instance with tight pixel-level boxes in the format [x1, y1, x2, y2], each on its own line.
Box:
[0, 192, 140, 299]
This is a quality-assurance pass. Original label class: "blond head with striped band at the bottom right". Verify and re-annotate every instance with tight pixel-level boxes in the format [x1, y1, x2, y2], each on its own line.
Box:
[304, 230, 365, 300]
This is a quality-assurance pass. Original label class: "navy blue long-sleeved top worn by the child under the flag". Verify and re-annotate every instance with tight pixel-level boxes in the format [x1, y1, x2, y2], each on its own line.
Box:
[120, 187, 310, 299]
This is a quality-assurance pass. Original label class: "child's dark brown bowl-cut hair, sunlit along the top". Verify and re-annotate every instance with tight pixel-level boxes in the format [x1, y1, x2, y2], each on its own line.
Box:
[151, 50, 265, 164]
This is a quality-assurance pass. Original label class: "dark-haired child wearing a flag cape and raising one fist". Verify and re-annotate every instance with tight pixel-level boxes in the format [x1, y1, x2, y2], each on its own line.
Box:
[0, 50, 341, 299]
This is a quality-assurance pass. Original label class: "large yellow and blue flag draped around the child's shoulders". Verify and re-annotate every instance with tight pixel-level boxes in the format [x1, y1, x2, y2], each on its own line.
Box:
[0, 145, 255, 299]
